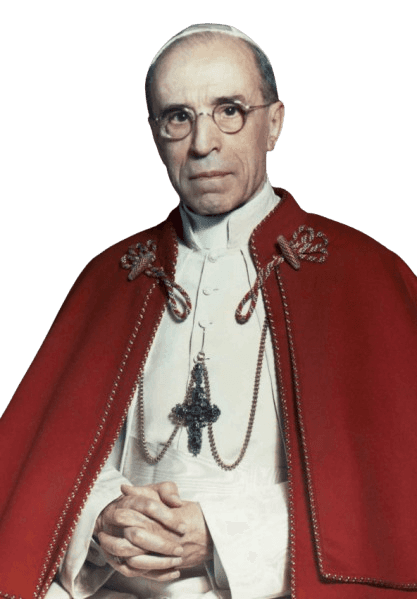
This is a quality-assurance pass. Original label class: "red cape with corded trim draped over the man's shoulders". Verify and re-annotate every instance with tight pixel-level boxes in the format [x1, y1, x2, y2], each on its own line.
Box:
[0, 188, 417, 599]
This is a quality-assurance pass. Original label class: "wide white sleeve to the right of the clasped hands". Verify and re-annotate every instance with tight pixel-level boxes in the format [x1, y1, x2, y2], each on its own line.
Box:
[198, 482, 289, 599]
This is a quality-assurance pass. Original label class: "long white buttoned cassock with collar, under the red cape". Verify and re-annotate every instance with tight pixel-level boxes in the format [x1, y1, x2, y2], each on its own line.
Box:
[51, 177, 289, 599]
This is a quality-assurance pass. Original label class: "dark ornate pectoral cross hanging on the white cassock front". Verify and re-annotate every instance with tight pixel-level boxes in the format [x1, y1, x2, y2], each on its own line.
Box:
[172, 362, 220, 456]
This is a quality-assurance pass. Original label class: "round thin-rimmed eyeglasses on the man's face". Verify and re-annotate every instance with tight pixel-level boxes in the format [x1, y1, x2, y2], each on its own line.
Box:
[153, 100, 271, 140]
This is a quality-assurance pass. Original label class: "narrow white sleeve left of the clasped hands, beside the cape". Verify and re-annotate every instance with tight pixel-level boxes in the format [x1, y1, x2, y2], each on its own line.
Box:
[58, 426, 130, 599]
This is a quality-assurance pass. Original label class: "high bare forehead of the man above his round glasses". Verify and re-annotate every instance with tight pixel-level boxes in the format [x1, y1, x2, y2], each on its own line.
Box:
[151, 35, 261, 107]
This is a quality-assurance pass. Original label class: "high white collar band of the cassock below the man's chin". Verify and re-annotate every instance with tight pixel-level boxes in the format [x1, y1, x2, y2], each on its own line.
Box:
[180, 175, 280, 250]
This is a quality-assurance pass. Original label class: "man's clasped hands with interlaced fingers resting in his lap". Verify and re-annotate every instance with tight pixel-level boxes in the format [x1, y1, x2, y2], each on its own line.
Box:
[94, 482, 213, 582]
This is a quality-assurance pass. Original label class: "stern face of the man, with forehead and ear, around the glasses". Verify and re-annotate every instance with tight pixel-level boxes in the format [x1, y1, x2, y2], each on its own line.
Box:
[151, 36, 284, 215]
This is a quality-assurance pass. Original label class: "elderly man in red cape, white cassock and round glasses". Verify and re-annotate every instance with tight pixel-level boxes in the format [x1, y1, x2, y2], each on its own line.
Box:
[0, 25, 417, 599]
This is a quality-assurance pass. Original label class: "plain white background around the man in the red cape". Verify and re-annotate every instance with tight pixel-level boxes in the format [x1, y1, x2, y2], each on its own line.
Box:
[0, 0, 417, 412]
